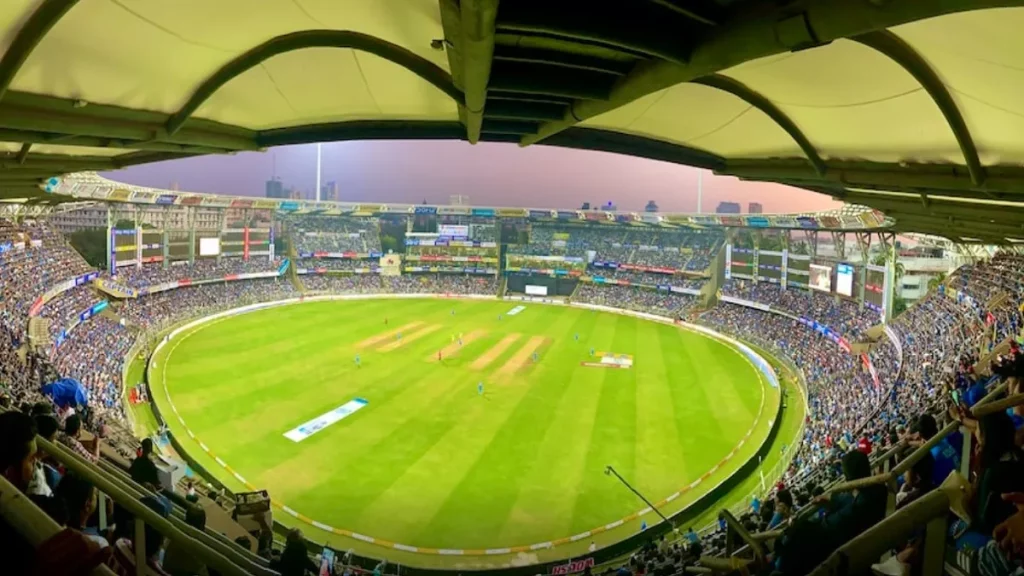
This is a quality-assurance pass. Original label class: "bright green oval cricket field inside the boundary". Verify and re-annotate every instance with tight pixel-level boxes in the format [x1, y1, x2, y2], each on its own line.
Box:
[150, 299, 779, 566]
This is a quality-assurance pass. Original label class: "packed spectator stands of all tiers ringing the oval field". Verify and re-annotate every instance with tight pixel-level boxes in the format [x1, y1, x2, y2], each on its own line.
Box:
[0, 217, 1024, 576]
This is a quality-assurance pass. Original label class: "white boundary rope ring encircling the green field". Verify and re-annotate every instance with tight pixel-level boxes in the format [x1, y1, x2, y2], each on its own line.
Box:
[146, 294, 781, 556]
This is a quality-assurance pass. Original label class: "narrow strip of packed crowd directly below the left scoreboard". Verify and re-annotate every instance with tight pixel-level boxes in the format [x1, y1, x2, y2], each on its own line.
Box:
[112, 257, 282, 290]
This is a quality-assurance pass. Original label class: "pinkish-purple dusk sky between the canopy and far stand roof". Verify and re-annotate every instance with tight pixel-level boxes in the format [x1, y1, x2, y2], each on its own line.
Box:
[104, 140, 839, 212]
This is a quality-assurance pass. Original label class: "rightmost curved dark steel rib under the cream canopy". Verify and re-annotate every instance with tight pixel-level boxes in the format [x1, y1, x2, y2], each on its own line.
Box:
[850, 30, 986, 187]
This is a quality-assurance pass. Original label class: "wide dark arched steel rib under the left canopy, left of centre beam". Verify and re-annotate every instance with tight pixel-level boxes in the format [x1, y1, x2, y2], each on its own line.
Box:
[165, 30, 464, 136]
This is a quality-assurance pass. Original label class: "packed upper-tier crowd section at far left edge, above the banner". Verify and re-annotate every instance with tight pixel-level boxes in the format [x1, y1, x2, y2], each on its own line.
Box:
[0, 220, 92, 340]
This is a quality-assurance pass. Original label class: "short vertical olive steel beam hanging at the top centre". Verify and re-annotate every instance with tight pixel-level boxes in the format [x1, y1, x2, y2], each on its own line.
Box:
[460, 0, 498, 143]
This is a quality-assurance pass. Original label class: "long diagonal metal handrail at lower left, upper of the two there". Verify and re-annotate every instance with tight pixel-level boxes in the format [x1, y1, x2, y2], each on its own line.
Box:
[37, 438, 278, 576]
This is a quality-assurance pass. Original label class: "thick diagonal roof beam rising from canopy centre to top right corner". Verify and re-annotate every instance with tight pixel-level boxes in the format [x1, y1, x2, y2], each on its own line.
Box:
[520, 0, 1024, 146]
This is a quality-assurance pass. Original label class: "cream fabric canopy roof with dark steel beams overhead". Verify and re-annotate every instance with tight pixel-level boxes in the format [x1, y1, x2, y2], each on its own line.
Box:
[6, 0, 1024, 243]
